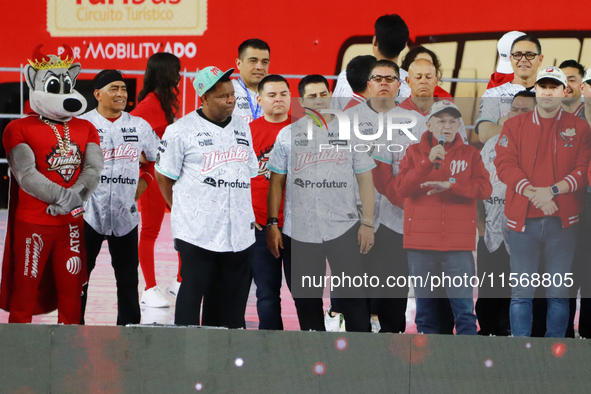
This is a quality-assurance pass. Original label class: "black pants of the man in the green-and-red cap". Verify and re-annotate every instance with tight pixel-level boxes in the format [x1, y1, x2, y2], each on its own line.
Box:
[174, 239, 255, 328]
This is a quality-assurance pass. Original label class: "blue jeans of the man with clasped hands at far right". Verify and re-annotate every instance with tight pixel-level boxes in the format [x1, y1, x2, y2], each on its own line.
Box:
[509, 216, 578, 338]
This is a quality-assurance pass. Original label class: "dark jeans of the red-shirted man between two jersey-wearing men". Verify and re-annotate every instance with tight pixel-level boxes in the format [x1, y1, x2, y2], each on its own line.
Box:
[251, 227, 283, 330]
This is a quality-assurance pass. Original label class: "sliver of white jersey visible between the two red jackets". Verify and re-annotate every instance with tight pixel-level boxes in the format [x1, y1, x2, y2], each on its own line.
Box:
[480, 135, 509, 253]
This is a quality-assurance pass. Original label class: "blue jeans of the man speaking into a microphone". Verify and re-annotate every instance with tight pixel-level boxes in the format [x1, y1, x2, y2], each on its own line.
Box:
[408, 249, 476, 335]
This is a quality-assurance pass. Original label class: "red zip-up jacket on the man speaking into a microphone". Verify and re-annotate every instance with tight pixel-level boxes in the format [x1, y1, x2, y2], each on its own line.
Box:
[388, 132, 492, 251]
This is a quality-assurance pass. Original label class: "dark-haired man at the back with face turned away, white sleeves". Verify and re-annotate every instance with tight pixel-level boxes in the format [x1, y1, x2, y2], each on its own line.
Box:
[331, 14, 410, 111]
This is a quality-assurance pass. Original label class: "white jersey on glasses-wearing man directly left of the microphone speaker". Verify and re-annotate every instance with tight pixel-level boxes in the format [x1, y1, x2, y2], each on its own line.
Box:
[373, 107, 428, 234]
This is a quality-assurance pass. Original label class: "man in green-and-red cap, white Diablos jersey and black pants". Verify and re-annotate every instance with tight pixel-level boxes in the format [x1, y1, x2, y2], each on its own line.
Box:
[155, 67, 259, 328]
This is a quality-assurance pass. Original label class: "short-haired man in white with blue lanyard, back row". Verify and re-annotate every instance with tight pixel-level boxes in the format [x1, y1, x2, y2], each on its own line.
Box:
[232, 38, 271, 123]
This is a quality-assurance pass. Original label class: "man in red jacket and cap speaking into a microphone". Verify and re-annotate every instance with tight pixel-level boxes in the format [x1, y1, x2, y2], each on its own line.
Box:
[395, 100, 492, 335]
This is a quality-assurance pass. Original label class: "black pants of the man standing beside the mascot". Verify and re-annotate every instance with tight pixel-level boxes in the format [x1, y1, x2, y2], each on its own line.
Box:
[80, 222, 141, 326]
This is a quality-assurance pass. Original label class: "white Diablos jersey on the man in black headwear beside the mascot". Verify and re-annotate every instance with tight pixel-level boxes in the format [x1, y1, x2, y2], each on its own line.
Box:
[80, 109, 159, 237]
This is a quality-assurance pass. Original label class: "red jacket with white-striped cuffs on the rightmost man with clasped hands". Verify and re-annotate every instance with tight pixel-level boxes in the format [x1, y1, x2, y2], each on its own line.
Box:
[495, 107, 591, 231]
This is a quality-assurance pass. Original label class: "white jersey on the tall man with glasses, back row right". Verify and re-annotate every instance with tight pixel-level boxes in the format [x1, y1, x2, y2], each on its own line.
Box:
[476, 82, 534, 127]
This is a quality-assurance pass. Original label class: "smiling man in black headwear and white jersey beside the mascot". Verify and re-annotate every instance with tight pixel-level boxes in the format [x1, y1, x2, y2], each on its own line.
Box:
[81, 70, 159, 325]
